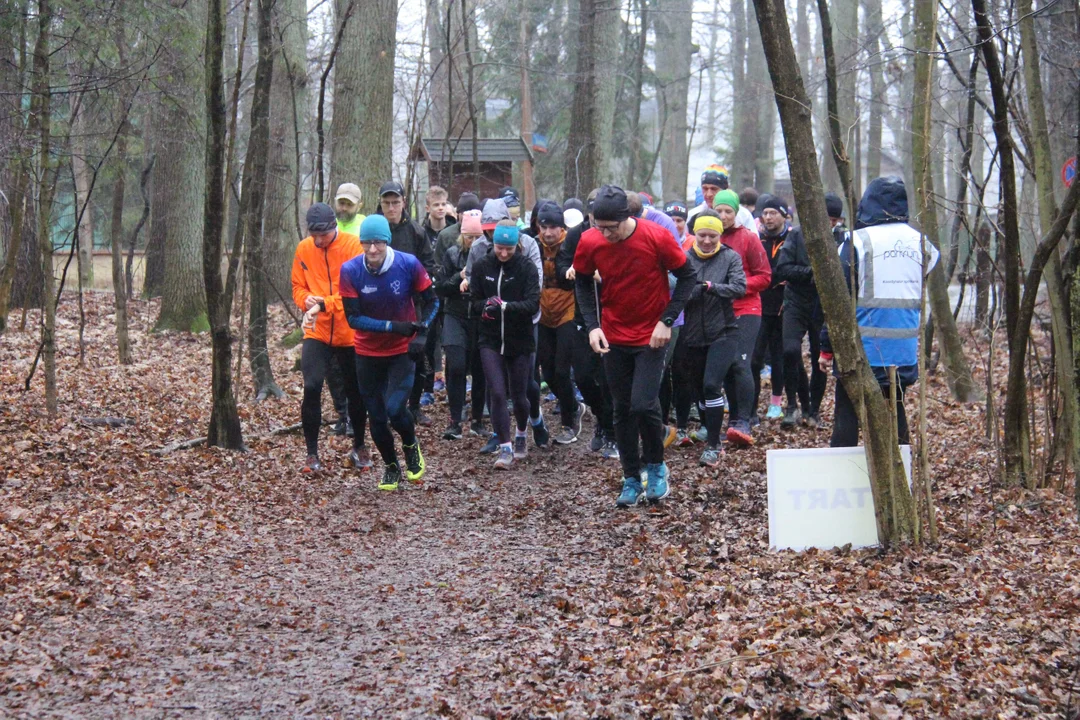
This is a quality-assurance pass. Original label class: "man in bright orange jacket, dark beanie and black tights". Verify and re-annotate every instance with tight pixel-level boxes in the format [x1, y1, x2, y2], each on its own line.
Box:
[293, 203, 372, 473]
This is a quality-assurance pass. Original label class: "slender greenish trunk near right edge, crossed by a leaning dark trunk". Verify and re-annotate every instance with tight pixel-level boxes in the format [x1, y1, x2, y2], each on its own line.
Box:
[1016, 0, 1080, 490]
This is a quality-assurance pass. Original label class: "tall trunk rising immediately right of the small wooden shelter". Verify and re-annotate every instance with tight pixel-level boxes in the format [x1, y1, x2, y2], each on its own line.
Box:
[563, 0, 622, 198]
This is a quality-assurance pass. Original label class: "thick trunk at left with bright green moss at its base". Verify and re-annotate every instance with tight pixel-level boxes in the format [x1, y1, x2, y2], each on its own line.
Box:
[150, 0, 210, 332]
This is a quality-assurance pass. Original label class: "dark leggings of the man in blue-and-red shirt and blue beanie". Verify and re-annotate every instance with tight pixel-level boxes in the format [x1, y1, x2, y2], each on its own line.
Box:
[356, 353, 416, 465]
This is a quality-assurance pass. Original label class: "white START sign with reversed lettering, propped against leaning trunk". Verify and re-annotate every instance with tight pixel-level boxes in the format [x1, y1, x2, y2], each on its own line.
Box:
[766, 445, 912, 551]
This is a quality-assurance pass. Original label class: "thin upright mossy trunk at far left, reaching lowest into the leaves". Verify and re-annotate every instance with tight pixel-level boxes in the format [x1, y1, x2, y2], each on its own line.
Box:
[30, 0, 56, 416]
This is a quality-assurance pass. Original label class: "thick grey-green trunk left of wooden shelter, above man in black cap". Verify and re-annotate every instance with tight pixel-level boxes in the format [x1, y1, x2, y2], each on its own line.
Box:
[329, 0, 397, 202]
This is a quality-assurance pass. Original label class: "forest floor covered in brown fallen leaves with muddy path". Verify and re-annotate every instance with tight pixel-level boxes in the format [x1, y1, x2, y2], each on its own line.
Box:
[0, 295, 1080, 718]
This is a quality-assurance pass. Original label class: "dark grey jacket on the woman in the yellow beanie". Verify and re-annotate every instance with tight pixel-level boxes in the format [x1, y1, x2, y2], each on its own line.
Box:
[679, 244, 746, 348]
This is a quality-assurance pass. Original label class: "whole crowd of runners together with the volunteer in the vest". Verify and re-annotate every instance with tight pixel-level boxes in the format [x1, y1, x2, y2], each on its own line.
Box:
[293, 165, 936, 506]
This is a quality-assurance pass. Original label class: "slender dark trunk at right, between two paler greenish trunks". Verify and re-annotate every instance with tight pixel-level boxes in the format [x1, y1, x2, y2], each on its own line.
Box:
[971, 0, 1023, 485]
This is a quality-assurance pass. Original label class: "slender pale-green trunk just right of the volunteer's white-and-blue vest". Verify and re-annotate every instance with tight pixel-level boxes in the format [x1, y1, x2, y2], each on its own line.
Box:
[912, 0, 981, 403]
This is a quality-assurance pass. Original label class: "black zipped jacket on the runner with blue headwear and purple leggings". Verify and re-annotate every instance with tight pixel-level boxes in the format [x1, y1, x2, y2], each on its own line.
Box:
[469, 253, 540, 357]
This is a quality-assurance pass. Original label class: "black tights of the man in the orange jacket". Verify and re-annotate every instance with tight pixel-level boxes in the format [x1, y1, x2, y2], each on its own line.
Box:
[300, 338, 367, 456]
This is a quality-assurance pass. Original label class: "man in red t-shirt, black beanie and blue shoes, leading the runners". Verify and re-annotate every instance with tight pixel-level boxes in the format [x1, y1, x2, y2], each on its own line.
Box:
[573, 185, 694, 507]
